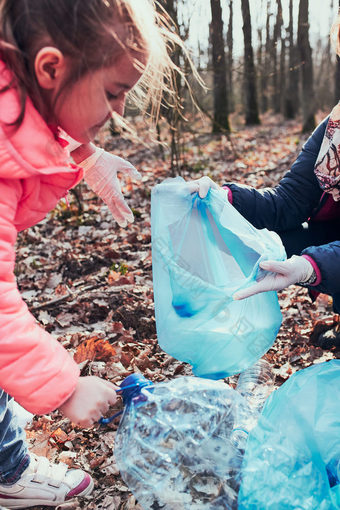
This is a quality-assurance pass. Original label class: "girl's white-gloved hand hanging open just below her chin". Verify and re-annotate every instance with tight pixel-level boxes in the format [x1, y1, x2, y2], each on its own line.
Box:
[80, 148, 141, 227]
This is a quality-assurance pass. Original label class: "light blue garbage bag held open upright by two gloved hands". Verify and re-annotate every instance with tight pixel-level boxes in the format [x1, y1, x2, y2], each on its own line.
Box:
[151, 177, 286, 379]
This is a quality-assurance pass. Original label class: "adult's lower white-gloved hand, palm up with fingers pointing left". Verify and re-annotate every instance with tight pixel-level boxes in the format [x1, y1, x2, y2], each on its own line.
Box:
[233, 255, 314, 300]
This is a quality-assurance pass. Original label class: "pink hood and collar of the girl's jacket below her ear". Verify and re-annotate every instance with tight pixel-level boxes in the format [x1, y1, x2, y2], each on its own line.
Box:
[0, 61, 79, 179]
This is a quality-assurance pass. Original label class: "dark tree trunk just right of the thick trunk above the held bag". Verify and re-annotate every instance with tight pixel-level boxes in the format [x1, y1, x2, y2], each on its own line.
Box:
[241, 0, 260, 125]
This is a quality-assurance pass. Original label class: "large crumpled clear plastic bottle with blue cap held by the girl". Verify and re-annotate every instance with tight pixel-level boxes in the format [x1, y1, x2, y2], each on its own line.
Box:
[115, 374, 250, 510]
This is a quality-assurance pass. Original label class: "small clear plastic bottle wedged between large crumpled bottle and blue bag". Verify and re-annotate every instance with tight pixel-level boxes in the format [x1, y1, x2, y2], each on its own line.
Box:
[231, 359, 275, 451]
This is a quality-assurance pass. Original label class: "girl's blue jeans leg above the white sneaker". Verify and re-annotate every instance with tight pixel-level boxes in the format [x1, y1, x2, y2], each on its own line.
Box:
[0, 389, 29, 484]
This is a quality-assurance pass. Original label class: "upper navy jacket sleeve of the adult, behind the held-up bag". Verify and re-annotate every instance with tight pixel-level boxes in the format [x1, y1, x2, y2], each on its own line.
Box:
[227, 118, 328, 231]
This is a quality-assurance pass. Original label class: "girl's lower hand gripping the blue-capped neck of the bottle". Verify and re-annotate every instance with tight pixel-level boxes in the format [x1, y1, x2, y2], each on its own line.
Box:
[59, 376, 117, 428]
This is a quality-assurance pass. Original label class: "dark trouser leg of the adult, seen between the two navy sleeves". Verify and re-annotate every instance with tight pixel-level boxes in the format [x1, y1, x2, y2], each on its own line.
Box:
[278, 221, 340, 257]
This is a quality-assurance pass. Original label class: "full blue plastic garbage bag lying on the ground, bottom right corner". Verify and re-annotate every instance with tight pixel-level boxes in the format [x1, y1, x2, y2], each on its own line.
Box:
[238, 360, 340, 510]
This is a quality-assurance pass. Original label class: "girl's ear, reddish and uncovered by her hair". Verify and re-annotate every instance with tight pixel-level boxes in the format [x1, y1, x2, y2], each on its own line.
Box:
[34, 46, 66, 90]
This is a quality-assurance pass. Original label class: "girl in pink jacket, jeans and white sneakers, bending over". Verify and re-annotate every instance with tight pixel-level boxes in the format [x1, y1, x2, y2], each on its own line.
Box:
[0, 0, 181, 508]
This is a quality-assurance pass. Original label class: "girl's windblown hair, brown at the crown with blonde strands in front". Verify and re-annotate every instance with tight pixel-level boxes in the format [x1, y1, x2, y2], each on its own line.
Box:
[0, 0, 183, 127]
